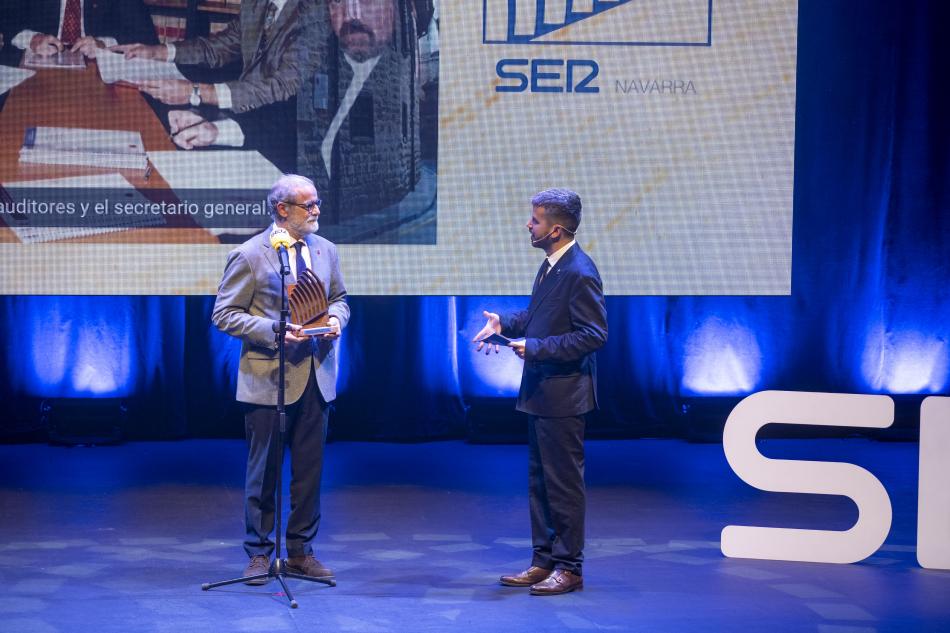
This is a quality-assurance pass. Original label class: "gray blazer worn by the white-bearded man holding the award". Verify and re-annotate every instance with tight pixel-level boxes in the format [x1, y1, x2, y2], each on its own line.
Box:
[211, 229, 350, 406]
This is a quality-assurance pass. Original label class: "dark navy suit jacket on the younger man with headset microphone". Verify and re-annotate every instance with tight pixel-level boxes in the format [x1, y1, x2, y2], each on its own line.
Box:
[502, 243, 607, 418]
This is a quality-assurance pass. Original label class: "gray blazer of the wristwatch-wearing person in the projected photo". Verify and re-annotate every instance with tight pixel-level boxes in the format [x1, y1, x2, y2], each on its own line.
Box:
[175, 0, 317, 112]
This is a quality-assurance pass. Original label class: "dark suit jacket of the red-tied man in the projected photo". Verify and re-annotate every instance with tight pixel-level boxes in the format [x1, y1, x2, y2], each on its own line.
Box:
[10, 0, 158, 44]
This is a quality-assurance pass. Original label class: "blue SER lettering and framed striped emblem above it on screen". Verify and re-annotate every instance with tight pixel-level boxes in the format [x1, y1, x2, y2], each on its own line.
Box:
[490, 0, 712, 94]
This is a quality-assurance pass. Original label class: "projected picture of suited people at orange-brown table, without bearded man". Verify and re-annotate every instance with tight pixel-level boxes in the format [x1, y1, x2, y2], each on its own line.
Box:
[0, 0, 329, 244]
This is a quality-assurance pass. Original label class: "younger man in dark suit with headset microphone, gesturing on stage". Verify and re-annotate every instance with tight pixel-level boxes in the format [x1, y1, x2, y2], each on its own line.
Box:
[475, 189, 607, 595]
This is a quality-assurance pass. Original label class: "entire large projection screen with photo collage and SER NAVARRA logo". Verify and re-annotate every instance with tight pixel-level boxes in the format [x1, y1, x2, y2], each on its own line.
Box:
[0, 0, 798, 296]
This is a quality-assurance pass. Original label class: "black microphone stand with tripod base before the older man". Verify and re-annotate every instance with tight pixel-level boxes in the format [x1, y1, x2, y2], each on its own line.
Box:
[201, 246, 336, 609]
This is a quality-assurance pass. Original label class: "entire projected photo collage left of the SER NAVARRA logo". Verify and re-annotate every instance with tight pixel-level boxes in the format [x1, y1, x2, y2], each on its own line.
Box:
[0, 0, 438, 244]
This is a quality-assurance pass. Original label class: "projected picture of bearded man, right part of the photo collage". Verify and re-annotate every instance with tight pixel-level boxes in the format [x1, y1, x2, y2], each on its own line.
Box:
[297, 0, 439, 244]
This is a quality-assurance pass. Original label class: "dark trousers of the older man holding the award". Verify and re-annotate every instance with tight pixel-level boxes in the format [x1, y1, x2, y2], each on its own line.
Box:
[244, 369, 329, 557]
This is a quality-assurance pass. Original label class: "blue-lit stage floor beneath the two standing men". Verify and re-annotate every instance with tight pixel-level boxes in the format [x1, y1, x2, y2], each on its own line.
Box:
[0, 440, 950, 633]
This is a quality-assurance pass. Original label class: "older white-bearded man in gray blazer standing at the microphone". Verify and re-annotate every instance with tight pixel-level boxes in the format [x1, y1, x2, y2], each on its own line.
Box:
[211, 175, 350, 584]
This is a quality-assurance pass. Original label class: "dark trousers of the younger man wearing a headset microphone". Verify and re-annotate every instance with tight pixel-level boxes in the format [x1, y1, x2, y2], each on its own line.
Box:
[528, 416, 587, 575]
